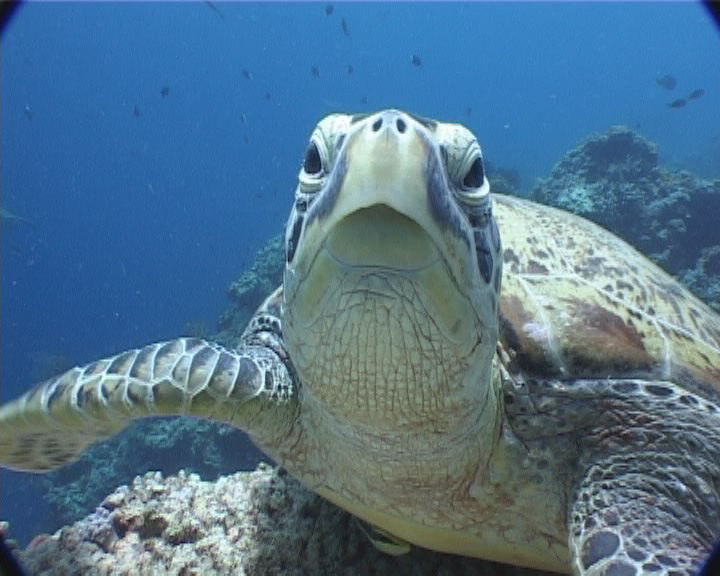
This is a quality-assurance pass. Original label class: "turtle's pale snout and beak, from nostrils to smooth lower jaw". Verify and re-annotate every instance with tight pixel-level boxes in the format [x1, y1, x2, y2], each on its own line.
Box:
[286, 110, 474, 286]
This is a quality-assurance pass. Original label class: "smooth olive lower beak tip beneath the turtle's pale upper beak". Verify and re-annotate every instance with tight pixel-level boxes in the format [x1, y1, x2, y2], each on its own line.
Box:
[324, 204, 442, 272]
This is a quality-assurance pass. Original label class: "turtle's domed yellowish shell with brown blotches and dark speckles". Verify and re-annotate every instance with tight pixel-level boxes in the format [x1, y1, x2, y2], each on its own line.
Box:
[495, 195, 720, 402]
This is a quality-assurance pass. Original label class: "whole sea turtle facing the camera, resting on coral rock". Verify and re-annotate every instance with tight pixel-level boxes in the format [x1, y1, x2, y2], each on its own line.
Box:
[0, 110, 720, 576]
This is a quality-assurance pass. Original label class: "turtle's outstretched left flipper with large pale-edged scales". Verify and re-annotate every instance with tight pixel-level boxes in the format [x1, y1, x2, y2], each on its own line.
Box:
[0, 338, 295, 472]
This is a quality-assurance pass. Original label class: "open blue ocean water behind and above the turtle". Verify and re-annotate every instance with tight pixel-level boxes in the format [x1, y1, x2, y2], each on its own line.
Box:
[0, 2, 720, 540]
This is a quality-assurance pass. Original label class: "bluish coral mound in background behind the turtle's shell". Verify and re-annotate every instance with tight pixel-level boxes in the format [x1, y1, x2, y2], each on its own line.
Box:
[530, 126, 720, 310]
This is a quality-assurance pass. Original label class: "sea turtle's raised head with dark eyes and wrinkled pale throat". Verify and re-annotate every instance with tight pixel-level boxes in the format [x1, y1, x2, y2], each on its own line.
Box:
[283, 110, 501, 431]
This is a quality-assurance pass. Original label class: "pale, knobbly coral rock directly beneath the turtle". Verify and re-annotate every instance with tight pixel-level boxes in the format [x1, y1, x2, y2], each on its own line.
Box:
[12, 465, 542, 576]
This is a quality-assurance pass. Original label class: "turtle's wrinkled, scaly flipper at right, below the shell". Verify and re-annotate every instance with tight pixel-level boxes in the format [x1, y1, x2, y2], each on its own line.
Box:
[569, 380, 720, 576]
